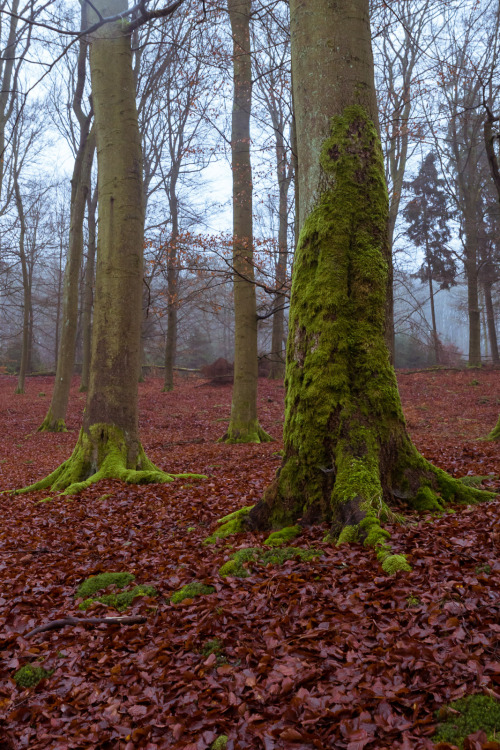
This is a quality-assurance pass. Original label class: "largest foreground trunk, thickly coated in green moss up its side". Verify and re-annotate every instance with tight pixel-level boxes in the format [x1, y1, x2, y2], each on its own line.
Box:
[244, 0, 490, 572]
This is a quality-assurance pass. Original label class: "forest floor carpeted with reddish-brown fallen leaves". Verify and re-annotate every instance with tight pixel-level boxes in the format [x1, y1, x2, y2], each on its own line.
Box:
[0, 370, 500, 750]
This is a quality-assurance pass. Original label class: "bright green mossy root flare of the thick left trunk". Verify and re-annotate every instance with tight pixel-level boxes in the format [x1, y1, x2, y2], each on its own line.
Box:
[16, 424, 205, 495]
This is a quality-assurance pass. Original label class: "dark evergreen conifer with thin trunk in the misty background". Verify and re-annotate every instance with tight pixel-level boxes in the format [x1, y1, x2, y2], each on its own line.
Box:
[403, 152, 457, 364]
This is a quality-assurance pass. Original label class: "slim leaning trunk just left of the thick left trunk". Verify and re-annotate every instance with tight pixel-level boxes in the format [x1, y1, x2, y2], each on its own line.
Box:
[38, 126, 95, 432]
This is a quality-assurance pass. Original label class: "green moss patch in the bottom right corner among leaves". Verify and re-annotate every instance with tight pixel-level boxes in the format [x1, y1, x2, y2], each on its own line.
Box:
[432, 695, 500, 748]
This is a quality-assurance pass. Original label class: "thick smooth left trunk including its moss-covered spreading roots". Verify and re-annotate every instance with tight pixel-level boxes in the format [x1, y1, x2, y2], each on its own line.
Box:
[21, 0, 201, 494]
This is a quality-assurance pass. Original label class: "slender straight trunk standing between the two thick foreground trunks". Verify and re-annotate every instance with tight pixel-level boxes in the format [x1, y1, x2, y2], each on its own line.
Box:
[222, 0, 269, 443]
